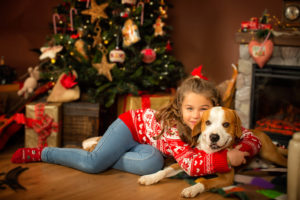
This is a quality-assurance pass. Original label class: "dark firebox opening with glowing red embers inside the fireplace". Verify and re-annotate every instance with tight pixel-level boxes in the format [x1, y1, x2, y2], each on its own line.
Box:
[250, 64, 300, 146]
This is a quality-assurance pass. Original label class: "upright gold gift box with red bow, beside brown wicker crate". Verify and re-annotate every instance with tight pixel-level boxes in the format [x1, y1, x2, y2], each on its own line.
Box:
[25, 102, 61, 147]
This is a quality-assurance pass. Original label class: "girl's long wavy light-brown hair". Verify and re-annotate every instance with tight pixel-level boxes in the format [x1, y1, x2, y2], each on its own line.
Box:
[155, 76, 222, 145]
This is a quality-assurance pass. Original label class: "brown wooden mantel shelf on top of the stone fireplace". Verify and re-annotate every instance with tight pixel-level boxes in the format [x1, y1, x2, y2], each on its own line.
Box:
[235, 31, 300, 47]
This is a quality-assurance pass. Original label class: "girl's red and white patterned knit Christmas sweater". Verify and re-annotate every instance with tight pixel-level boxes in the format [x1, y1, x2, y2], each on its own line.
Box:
[119, 109, 261, 176]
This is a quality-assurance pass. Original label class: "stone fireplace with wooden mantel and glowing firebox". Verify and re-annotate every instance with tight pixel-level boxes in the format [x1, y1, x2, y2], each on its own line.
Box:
[234, 31, 300, 145]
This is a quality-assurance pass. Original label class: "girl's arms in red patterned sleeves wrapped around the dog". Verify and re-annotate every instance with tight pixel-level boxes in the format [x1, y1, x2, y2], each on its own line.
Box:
[168, 128, 261, 176]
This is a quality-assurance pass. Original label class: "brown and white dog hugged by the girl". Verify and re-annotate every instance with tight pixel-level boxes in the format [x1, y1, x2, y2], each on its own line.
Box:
[138, 107, 287, 197]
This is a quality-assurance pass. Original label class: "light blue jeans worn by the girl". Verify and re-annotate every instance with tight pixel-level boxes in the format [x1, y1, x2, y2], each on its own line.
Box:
[42, 118, 164, 175]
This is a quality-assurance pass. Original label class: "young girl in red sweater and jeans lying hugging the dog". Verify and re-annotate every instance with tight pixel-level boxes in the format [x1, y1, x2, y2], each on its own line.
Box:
[12, 74, 260, 176]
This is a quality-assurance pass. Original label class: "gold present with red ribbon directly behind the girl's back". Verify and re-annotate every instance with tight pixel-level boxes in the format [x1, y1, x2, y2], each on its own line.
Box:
[118, 93, 174, 115]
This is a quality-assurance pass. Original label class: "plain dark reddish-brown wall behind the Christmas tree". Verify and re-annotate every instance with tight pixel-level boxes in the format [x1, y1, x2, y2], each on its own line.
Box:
[0, 0, 282, 82]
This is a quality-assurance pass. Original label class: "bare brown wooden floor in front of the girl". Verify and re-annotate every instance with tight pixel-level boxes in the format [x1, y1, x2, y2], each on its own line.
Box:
[0, 138, 234, 200]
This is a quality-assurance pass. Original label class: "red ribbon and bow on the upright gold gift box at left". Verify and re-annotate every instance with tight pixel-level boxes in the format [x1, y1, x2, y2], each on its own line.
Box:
[15, 103, 58, 147]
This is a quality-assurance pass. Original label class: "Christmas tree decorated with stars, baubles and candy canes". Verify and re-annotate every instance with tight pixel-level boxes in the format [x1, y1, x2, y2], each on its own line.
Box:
[40, 0, 185, 107]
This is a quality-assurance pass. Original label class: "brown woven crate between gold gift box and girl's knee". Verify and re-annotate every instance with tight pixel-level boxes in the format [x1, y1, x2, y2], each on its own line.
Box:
[63, 102, 100, 146]
